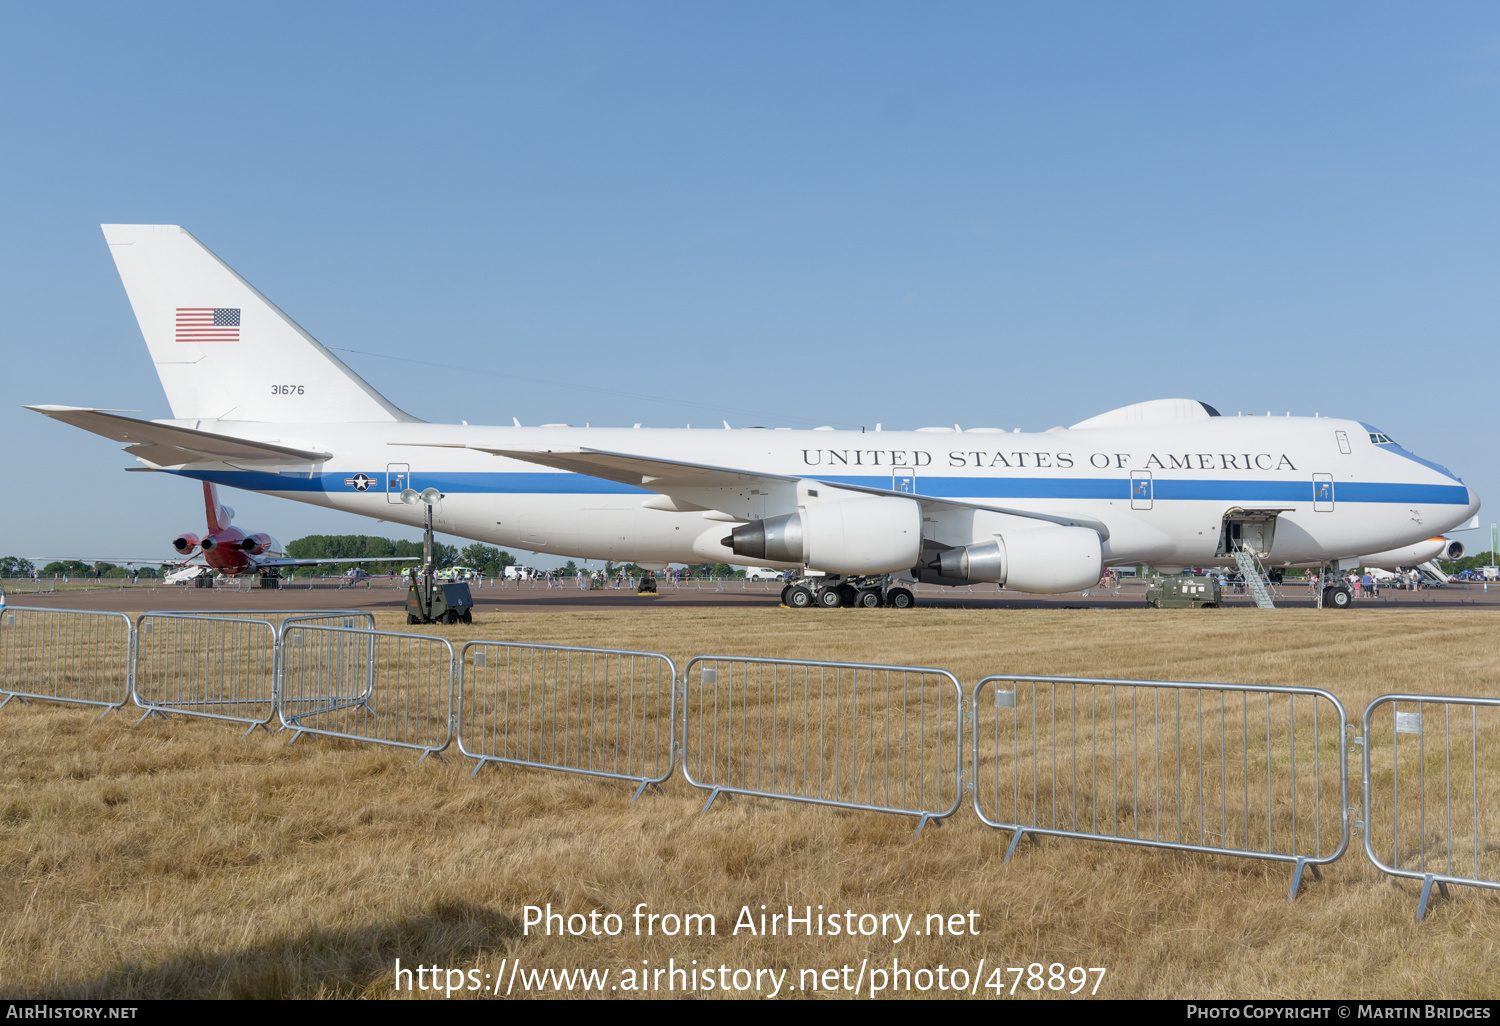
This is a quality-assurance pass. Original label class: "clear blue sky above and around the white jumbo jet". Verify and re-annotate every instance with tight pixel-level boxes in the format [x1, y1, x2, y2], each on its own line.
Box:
[0, 2, 1500, 555]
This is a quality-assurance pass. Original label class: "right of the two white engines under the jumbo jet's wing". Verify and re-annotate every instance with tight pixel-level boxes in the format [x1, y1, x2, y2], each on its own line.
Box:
[933, 527, 1104, 594]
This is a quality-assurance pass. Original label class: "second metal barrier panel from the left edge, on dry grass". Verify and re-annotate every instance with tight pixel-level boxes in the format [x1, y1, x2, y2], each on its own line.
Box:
[134, 612, 278, 734]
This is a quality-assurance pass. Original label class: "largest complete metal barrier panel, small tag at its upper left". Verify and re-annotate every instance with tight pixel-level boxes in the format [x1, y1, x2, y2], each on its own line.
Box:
[971, 674, 1350, 902]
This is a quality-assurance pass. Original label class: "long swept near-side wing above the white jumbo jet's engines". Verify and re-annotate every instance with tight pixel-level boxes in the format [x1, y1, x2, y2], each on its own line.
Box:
[468, 446, 1110, 540]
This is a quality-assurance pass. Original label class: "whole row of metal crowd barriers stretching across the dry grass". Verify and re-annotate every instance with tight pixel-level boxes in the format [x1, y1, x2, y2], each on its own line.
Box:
[0, 606, 1500, 921]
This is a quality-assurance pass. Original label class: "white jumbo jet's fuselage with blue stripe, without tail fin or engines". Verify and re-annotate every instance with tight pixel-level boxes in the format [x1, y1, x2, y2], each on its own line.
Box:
[155, 417, 1479, 566]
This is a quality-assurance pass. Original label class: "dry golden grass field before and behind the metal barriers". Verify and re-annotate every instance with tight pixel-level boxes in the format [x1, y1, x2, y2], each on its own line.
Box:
[0, 608, 1500, 999]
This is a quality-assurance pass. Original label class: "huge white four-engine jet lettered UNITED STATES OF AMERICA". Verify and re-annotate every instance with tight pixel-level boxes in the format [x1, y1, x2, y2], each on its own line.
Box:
[32, 225, 1479, 608]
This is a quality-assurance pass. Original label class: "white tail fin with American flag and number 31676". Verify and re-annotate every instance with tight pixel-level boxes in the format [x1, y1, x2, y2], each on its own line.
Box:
[101, 225, 417, 423]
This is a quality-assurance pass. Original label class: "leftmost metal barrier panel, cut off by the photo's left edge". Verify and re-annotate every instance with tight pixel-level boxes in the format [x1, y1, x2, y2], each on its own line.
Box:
[0, 606, 135, 717]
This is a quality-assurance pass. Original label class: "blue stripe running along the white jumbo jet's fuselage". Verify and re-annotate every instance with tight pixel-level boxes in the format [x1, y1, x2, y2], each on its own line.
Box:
[168, 470, 1469, 506]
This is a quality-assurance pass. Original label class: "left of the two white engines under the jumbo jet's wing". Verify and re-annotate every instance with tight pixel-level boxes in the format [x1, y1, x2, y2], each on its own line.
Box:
[725, 497, 923, 575]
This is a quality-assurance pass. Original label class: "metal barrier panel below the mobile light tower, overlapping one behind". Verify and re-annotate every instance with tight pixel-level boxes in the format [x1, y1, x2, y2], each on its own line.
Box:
[279, 621, 458, 759]
